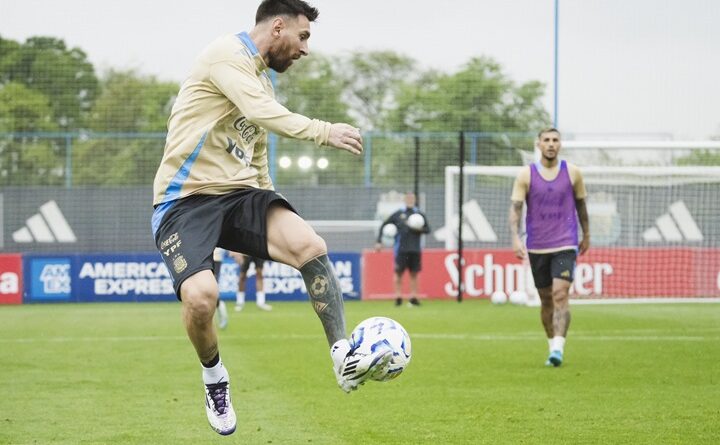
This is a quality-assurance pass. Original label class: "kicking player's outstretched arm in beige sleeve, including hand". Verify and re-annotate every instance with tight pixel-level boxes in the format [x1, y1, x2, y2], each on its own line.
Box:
[210, 59, 363, 154]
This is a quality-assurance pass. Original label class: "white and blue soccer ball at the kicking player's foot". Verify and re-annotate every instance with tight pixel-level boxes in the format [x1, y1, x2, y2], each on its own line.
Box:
[350, 317, 412, 382]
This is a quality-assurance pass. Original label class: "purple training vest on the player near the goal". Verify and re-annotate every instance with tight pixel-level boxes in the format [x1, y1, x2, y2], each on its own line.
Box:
[525, 161, 578, 250]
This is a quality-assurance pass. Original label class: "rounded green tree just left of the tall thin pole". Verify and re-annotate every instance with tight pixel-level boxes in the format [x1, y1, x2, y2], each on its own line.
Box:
[373, 57, 550, 181]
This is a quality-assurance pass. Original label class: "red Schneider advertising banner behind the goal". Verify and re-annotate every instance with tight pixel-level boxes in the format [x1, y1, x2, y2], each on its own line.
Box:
[362, 248, 720, 299]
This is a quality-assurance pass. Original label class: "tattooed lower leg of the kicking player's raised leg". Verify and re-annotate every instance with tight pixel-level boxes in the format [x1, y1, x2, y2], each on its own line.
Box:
[300, 254, 347, 345]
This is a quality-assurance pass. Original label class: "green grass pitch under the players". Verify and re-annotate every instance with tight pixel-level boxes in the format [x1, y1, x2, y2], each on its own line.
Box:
[0, 301, 720, 445]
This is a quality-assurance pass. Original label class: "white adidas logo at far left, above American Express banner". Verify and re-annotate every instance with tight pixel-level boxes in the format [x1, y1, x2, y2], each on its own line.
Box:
[13, 201, 77, 243]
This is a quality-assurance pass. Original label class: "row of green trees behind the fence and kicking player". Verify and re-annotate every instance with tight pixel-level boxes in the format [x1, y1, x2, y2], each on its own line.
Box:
[0, 37, 549, 185]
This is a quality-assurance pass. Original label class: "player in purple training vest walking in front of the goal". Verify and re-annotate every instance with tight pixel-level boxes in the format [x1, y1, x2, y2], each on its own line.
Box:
[509, 128, 590, 366]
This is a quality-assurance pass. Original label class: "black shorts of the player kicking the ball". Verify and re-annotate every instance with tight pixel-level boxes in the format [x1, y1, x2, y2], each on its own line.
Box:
[155, 189, 297, 299]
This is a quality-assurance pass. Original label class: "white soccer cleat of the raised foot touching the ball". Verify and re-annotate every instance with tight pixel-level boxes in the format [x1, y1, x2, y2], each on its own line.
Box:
[330, 339, 392, 392]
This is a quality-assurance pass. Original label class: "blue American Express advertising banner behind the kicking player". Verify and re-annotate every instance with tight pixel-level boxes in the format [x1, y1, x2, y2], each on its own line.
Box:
[23, 253, 360, 303]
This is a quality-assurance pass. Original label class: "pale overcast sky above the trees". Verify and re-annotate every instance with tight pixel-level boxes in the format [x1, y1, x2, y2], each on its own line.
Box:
[0, 0, 720, 139]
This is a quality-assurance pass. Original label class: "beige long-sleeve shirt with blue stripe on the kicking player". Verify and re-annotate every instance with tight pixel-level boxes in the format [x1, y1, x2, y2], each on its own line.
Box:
[153, 33, 330, 205]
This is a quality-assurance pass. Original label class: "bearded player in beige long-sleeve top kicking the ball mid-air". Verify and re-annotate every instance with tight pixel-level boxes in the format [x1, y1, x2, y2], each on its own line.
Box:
[152, 0, 392, 435]
